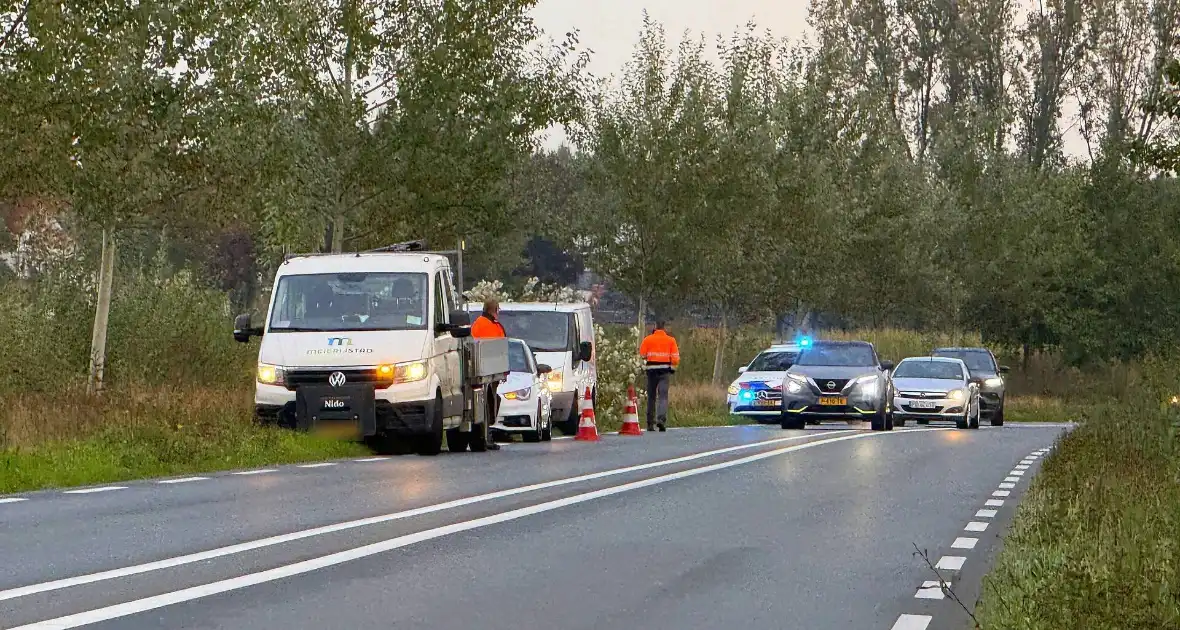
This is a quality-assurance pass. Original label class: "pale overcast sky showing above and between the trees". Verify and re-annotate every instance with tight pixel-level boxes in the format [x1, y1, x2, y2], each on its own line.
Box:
[533, 0, 1086, 156]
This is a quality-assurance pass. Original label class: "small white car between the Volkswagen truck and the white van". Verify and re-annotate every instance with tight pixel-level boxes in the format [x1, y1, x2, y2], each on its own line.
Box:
[491, 339, 553, 442]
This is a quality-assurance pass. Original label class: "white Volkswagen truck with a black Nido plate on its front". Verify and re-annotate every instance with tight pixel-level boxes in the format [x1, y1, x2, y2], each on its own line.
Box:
[234, 251, 507, 454]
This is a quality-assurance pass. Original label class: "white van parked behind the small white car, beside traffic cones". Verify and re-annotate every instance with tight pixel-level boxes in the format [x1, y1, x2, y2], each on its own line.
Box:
[467, 302, 598, 435]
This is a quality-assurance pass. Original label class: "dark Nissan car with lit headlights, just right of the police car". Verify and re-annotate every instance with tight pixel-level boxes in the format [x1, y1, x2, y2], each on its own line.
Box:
[781, 341, 893, 431]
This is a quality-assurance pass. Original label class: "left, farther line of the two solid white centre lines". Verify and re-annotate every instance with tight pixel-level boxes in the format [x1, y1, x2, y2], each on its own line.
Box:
[0, 429, 887, 602]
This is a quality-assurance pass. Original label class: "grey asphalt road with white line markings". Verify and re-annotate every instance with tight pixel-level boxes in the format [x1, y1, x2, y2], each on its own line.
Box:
[0, 425, 1066, 630]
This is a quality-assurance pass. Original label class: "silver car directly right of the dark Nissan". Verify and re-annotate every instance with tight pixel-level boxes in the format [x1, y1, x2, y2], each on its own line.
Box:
[889, 356, 979, 428]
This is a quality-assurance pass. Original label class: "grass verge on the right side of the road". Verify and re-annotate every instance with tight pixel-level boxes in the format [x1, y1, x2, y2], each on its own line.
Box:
[977, 403, 1180, 630]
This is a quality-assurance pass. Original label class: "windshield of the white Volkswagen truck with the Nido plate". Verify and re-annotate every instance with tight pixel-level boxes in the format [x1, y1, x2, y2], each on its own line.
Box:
[269, 273, 430, 333]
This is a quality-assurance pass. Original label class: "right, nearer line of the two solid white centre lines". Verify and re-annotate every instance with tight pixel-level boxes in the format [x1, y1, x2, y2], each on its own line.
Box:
[8, 428, 945, 630]
